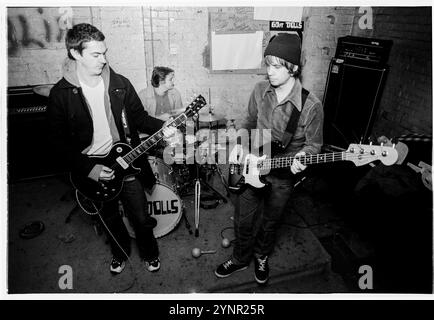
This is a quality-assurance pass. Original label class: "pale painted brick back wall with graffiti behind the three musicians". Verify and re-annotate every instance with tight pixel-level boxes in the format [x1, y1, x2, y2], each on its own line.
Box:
[8, 7, 354, 118]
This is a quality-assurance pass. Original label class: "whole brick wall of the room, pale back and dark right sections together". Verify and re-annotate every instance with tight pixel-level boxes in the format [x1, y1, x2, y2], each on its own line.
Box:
[8, 7, 432, 136]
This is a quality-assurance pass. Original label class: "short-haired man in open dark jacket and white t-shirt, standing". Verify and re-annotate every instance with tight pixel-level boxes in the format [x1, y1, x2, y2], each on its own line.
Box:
[47, 23, 176, 274]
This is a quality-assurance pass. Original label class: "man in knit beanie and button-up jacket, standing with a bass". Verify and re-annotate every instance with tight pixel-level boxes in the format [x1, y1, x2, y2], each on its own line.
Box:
[215, 33, 324, 284]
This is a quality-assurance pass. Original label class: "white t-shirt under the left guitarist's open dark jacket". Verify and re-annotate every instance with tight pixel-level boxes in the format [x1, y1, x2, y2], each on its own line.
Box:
[80, 79, 113, 155]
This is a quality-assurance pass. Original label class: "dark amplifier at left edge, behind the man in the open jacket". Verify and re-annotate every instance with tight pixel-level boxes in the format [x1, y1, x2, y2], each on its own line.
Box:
[7, 86, 66, 182]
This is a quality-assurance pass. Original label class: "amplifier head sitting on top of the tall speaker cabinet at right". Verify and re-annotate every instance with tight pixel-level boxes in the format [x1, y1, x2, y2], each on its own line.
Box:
[335, 36, 393, 65]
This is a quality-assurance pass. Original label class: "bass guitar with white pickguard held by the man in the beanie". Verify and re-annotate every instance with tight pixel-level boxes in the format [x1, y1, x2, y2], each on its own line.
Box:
[229, 144, 398, 193]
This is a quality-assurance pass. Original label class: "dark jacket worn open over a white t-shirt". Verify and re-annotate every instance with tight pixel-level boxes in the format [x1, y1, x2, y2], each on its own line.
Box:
[47, 59, 163, 187]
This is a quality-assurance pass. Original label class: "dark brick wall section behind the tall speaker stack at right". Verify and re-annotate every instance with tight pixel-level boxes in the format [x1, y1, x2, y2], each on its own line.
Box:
[353, 7, 432, 137]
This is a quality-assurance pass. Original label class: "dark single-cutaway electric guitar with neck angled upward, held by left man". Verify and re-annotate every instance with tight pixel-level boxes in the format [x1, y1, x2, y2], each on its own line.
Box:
[70, 95, 206, 202]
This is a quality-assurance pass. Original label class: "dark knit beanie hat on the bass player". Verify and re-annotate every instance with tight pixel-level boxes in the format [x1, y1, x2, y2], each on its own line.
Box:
[264, 33, 301, 66]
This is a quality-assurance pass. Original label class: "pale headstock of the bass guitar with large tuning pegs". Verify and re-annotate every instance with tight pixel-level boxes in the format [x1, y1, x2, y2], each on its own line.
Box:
[346, 143, 398, 166]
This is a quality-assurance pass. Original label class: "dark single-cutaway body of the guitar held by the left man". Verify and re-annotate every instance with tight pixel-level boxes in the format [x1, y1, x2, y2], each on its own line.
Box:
[70, 142, 140, 202]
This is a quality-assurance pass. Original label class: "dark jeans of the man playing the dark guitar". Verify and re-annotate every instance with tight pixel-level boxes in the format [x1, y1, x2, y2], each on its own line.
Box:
[101, 179, 159, 261]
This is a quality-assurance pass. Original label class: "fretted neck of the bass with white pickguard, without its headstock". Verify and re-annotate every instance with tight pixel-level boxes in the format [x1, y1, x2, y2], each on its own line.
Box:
[261, 151, 347, 170]
